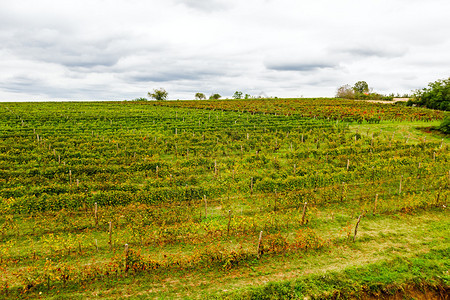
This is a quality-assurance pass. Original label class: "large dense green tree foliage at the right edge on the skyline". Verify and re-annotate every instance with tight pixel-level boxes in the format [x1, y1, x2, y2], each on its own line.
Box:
[408, 77, 450, 110]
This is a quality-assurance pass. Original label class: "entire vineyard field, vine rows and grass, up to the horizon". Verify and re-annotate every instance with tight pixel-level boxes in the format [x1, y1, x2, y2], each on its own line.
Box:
[0, 99, 450, 299]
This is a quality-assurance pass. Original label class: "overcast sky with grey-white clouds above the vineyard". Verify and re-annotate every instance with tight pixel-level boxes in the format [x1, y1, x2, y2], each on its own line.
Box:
[0, 0, 450, 102]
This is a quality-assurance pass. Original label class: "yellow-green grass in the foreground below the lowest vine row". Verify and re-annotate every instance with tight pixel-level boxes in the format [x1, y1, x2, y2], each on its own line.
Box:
[1, 208, 450, 299]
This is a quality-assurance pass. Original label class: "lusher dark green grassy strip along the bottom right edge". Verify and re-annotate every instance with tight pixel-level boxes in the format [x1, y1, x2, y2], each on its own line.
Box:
[216, 248, 450, 299]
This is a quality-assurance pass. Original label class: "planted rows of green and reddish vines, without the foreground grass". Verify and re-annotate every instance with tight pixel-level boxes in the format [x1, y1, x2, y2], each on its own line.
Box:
[0, 99, 450, 294]
